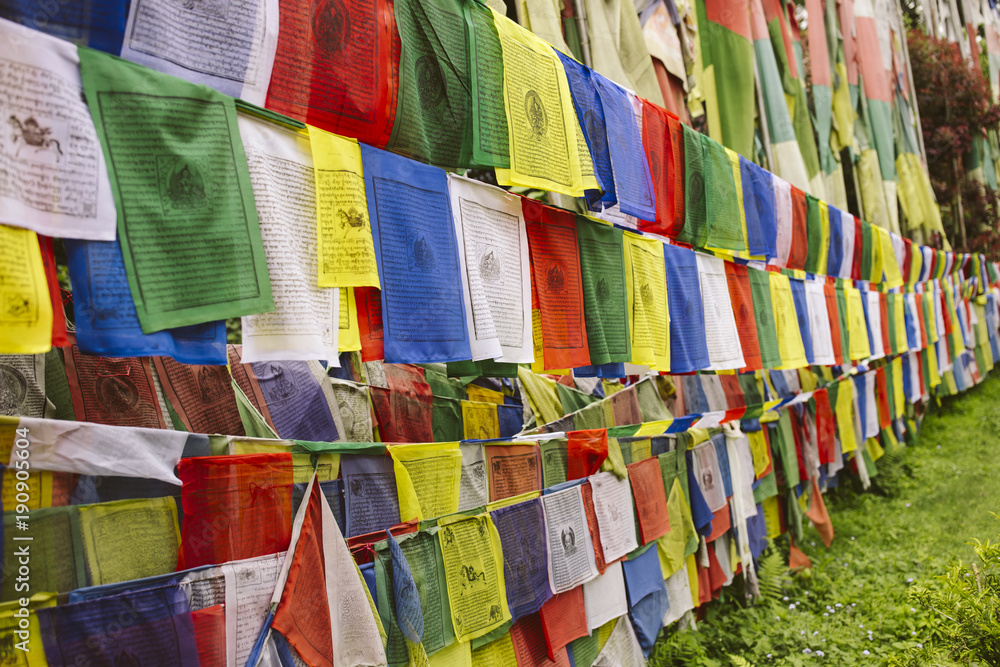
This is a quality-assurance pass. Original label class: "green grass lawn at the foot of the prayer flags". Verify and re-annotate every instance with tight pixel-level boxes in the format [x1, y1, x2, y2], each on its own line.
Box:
[650, 374, 1000, 667]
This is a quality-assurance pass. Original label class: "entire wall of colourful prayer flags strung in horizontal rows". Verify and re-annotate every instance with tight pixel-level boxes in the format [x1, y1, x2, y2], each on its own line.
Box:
[0, 0, 1000, 666]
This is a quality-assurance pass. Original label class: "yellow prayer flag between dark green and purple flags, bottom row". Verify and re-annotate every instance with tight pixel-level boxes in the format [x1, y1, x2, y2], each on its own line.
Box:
[438, 514, 511, 642]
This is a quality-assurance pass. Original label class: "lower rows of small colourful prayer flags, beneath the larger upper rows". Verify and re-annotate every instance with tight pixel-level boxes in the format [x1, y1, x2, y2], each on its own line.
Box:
[0, 320, 1000, 666]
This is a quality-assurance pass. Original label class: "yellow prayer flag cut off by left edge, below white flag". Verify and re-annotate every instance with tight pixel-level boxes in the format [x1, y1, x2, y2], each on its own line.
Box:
[0, 225, 52, 354]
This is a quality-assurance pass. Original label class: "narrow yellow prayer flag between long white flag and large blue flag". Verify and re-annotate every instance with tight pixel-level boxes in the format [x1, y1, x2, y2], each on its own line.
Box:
[307, 126, 379, 288]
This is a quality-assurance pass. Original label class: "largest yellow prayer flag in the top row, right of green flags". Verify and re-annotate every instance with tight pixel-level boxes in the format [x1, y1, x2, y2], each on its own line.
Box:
[493, 12, 598, 197]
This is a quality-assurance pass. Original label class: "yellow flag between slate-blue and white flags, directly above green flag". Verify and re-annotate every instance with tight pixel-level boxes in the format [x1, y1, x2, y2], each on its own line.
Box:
[387, 442, 462, 521]
